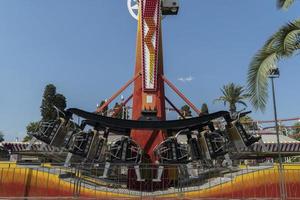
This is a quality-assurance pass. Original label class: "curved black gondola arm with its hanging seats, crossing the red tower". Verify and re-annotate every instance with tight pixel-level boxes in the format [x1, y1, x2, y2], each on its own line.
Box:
[26, 106, 260, 181]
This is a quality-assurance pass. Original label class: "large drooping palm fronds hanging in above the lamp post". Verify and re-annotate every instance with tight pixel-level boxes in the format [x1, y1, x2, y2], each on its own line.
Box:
[247, 0, 300, 111]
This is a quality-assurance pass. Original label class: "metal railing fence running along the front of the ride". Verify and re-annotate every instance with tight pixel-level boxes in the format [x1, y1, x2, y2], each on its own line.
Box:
[0, 163, 300, 199]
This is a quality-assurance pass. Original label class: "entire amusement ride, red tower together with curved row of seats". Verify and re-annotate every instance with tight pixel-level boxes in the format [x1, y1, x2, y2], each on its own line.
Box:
[26, 0, 268, 191]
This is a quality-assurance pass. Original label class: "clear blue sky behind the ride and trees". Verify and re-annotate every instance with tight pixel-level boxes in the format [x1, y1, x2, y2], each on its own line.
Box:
[0, 0, 300, 140]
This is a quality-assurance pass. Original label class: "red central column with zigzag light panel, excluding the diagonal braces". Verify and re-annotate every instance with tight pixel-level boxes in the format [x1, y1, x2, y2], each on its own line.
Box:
[129, 0, 167, 189]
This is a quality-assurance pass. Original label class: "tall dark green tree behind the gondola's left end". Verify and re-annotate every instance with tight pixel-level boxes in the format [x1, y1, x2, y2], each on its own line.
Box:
[41, 84, 67, 121]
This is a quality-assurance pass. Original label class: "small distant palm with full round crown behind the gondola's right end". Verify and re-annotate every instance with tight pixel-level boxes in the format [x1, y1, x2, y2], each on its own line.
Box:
[214, 83, 249, 114]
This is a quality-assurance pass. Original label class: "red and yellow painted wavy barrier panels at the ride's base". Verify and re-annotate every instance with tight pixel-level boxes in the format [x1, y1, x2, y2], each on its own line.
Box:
[0, 163, 300, 199]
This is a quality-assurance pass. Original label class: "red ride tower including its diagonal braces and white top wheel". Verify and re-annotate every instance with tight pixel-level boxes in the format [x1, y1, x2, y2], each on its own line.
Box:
[97, 0, 200, 188]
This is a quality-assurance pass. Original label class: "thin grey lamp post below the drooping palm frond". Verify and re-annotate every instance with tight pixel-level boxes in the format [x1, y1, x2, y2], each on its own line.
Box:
[268, 68, 285, 199]
